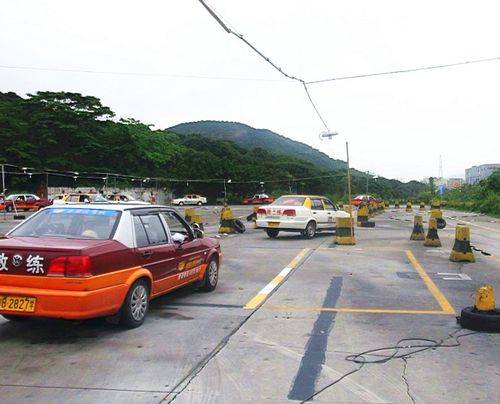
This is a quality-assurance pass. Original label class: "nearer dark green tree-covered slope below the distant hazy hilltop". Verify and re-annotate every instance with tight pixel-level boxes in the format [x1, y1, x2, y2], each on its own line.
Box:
[0, 92, 424, 201]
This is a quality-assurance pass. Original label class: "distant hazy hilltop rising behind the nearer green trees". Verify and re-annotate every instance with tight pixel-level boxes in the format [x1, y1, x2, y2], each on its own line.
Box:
[169, 121, 346, 170]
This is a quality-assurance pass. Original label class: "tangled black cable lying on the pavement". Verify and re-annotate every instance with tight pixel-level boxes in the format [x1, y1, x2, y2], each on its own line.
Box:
[301, 329, 478, 403]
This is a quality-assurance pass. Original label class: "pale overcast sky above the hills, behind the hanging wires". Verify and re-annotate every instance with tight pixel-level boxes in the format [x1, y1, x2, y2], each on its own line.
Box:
[0, 0, 500, 180]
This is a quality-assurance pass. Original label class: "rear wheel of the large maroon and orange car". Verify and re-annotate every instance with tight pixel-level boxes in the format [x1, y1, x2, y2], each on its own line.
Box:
[120, 278, 149, 328]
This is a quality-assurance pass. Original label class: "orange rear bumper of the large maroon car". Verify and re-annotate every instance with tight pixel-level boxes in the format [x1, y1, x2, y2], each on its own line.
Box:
[0, 284, 128, 320]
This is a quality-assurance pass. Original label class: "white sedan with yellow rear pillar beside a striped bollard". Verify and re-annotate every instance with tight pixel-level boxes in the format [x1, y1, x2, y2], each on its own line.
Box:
[256, 195, 349, 238]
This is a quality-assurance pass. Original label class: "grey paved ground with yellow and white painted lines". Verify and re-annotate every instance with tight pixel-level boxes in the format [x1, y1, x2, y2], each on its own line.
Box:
[0, 207, 500, 403]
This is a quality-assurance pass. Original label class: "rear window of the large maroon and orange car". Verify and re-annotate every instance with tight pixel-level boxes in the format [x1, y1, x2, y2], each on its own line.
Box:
[9, 208, 120, 240]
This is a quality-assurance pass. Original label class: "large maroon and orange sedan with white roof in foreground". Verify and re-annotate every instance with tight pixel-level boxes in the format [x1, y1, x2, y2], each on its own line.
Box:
[0, 203, 221, 328]
